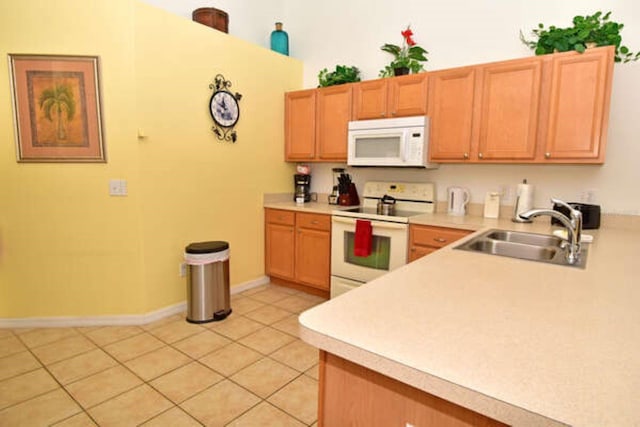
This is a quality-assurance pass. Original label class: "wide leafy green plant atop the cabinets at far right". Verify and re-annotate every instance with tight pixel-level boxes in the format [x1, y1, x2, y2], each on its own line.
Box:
[520, 11, 640, 62]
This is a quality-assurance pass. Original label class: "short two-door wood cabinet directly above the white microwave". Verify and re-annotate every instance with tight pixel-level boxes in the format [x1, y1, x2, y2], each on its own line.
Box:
[353, 73, 428, 120]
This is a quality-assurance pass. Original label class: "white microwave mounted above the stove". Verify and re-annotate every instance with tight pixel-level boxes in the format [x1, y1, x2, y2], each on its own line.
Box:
[347, 116, 438, 168]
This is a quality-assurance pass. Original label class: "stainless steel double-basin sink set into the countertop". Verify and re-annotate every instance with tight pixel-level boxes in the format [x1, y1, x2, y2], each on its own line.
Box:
[454, 229, 587, 268]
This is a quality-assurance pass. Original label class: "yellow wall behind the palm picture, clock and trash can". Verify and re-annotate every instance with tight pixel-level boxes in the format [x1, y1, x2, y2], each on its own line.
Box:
[0, 0, 302, 318]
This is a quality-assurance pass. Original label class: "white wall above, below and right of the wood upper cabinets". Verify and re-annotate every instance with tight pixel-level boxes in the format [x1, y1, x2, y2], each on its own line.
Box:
[141, 0, 640, 215]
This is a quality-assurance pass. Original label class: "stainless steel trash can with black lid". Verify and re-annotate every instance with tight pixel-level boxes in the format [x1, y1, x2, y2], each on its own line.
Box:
[184, 241, 231, 323]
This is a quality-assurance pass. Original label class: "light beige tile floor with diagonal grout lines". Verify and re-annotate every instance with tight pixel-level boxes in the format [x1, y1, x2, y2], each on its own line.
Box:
[0, 285, 324, 427]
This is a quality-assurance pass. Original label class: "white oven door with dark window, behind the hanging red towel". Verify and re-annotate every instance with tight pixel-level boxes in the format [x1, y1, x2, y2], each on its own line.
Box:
[331, 216, 409, 282]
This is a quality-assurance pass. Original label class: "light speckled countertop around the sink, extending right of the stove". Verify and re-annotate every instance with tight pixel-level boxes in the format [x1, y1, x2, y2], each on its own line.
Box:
[300, 211, 640, 426]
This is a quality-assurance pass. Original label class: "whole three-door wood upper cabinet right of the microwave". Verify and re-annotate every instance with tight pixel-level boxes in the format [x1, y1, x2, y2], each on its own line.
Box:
[427, 47, 613, 163]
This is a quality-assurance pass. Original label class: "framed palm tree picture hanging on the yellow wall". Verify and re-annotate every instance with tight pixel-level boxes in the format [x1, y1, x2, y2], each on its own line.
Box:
[9, 54, 106, 163]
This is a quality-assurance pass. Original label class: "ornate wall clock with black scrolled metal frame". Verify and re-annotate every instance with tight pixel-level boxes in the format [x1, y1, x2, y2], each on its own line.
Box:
[209, 74, 242, 142]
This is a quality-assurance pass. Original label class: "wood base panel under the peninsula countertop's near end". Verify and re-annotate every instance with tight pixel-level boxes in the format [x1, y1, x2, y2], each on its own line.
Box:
[318, 351, 505, 427]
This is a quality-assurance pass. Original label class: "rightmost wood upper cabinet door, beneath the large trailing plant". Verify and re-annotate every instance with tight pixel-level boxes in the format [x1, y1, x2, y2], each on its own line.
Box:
[542, 46, 614, 163]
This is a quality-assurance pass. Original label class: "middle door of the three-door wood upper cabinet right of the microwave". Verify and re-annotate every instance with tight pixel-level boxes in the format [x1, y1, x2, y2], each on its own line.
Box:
[477, 58, 542, 161]
